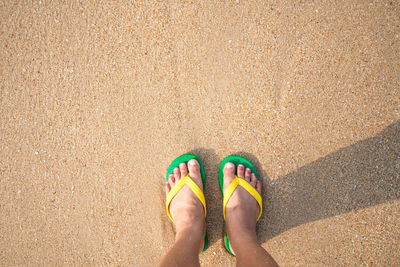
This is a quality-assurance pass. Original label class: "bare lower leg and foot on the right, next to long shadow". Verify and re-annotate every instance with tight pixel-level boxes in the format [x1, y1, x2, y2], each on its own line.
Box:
[224, 163, 278, 266]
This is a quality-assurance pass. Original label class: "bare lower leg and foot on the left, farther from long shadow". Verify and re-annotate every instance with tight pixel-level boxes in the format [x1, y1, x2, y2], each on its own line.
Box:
[160, 159, 206, 267]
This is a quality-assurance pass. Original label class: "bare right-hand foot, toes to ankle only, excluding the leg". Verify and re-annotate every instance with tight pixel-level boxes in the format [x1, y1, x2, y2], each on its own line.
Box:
[223, 162, 261, 253]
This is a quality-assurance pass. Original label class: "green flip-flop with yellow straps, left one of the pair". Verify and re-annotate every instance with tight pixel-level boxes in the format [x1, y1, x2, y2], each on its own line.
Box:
[165, 154, 208, 253]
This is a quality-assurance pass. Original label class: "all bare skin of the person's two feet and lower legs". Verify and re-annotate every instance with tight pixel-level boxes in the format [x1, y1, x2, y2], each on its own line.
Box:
[160, 159, 278, 266]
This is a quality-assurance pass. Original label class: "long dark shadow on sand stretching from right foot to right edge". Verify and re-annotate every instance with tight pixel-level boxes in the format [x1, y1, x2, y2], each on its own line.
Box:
[237, 121, 400, 243]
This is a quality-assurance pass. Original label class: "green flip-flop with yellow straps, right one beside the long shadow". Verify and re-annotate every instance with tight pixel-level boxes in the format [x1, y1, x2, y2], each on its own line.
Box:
[218, 155, 262, 255]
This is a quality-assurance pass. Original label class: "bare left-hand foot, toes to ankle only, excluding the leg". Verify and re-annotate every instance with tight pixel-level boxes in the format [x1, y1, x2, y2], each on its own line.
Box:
[165, 159, 206, 253]
